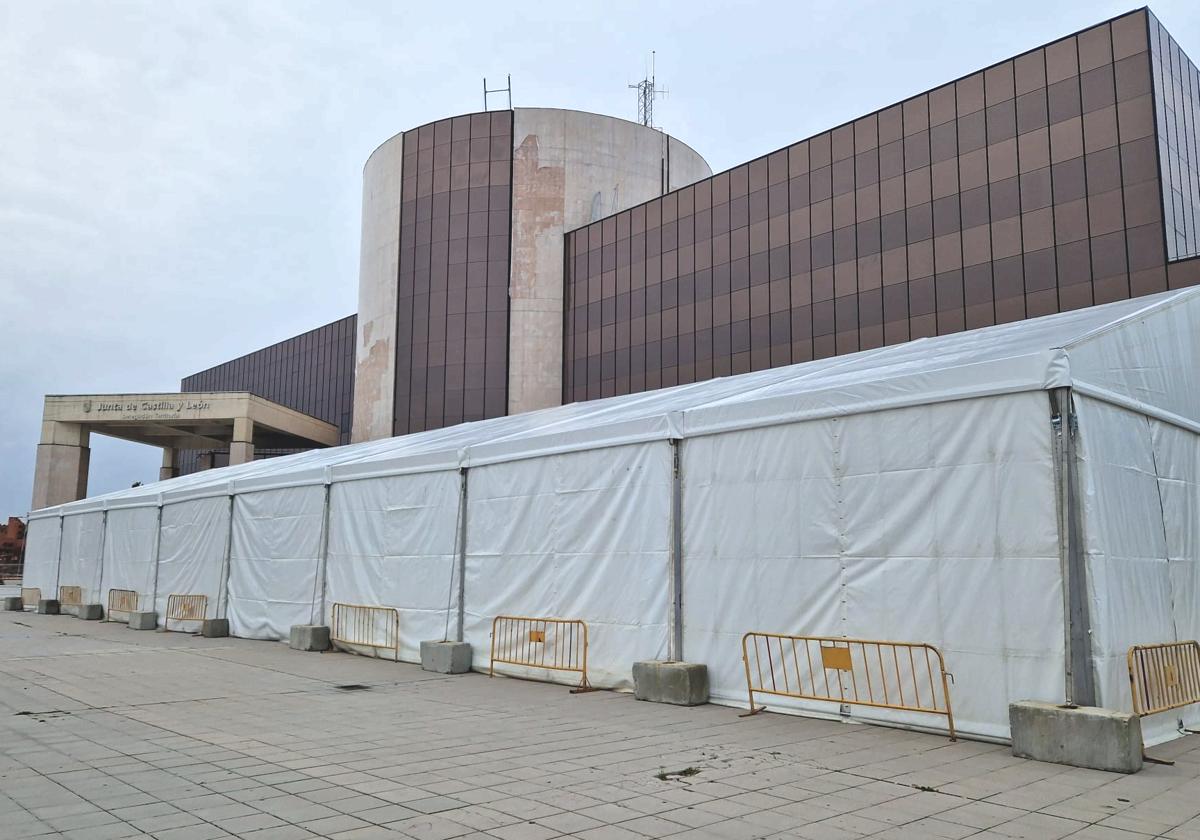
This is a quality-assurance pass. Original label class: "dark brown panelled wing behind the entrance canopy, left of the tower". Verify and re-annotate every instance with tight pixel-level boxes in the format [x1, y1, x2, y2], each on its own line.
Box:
[176, 316, 358, 475]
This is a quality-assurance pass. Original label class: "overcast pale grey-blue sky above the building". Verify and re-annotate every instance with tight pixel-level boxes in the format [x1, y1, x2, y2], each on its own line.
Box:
[0, 0, 1200, 517]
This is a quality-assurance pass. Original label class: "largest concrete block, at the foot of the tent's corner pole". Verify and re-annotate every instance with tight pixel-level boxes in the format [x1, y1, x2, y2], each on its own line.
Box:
[1008, 700, 1142, 773]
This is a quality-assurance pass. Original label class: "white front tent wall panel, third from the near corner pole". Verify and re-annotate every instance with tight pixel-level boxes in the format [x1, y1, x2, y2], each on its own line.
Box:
[325, 470, 461, 661]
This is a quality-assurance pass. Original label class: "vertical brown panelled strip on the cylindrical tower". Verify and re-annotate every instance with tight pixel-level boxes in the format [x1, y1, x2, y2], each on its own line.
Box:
[392, 110, 512, 434]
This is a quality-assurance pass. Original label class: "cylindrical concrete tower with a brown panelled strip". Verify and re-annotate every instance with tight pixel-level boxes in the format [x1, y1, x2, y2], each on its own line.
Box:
[353, 108, 712, 442]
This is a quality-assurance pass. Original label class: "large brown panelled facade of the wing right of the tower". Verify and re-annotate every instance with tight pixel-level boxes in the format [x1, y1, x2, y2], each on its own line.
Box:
[563, 10, 1195, 402]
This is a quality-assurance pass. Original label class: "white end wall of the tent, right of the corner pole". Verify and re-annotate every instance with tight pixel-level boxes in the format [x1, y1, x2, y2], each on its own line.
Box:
[1075, 395, 1200, 743]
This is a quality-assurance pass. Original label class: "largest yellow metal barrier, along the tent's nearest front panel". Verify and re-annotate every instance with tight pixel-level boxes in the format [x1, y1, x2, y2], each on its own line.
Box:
[742, 632, 958, 740]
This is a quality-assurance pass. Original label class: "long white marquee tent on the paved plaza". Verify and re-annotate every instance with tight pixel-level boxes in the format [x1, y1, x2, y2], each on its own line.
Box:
[25, 290, 1200, 740]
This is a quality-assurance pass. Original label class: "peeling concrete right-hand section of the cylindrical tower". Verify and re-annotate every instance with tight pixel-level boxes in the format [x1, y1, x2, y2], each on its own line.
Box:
[508, 108, 712, 417]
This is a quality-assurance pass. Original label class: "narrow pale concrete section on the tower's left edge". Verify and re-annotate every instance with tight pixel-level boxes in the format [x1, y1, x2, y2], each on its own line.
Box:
[350, 134, 404, 443]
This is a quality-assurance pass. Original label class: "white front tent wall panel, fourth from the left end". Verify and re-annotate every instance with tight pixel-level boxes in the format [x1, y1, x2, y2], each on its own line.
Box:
[155, 496, 229, 630]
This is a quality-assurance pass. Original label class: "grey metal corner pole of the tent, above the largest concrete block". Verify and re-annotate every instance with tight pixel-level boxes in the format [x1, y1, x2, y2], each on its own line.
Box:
[1050, 388, 1096, 706]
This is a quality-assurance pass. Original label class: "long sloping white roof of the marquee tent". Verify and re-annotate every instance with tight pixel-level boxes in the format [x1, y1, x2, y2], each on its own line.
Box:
[30, 289, 1200, 518]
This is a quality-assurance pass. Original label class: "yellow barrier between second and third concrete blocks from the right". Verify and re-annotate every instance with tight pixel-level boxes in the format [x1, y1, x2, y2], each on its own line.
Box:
[488, 616, 594, 694]
